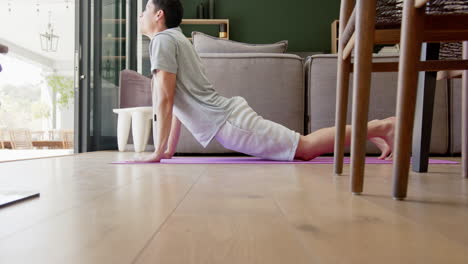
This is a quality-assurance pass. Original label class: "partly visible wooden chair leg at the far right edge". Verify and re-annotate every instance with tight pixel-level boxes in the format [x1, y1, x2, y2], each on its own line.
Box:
[462, 41, 468, 178]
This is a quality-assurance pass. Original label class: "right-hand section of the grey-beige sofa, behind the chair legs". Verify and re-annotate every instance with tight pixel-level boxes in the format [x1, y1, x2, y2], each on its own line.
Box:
[305, 55, 449, 154]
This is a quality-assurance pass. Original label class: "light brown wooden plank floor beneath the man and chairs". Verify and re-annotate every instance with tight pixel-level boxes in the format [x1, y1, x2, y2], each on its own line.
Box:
[0, 152, 468, 264]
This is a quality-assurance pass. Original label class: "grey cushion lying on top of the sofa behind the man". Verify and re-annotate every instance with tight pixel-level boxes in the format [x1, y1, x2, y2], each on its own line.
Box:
[192, 31, 288, 53]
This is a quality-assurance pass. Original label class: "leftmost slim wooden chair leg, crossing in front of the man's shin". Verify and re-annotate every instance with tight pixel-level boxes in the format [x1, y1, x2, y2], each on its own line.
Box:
[334, 0, 353, 175]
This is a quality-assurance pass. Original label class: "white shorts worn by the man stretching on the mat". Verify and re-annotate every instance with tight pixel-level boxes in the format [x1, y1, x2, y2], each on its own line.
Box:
[215, 96, 300, 161]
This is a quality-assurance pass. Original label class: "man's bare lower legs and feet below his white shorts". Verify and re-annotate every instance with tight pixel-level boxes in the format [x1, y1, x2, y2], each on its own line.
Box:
[294, 117, 395, 160]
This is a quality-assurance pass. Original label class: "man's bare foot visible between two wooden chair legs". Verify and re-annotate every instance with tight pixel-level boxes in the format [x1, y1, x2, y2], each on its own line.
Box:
[369, 116, 395, 160]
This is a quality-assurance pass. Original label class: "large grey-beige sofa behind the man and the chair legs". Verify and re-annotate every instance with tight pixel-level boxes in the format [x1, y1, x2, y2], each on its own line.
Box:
[121, 53, 461, 155]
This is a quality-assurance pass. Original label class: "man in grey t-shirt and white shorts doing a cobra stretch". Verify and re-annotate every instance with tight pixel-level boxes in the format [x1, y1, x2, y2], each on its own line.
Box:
[137, 0, 395, 162]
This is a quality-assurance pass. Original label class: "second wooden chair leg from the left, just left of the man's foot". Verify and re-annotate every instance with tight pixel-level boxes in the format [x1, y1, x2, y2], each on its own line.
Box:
[351, 0, 376, 194]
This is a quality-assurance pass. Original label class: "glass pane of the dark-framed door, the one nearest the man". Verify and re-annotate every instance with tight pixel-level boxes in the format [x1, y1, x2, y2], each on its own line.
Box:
[91, 0, 128, 150]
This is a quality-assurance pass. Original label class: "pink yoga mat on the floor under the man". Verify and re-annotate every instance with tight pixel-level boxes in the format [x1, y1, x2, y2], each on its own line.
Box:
[112, 157, 458, 164]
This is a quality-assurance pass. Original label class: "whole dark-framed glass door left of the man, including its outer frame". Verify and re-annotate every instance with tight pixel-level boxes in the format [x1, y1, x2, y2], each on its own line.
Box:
[75, 0, 137, 152]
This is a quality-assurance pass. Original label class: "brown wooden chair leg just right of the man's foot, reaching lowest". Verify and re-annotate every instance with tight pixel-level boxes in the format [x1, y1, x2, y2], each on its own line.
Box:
[393, 0, 424, 200]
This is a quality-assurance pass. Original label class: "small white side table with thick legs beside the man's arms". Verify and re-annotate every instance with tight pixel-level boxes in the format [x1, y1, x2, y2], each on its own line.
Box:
[113, 107, 153, 152]
